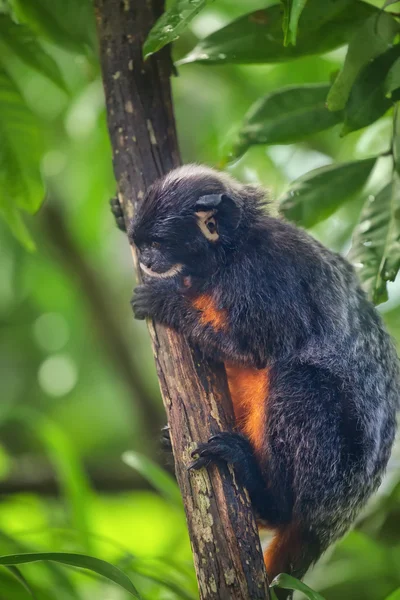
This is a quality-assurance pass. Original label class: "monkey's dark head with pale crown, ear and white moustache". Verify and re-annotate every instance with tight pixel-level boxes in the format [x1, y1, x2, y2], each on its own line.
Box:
[129, 165, 264, 278]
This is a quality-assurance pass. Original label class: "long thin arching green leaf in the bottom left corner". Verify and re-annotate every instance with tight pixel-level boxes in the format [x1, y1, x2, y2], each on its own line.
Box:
[0, 552, 140, 598]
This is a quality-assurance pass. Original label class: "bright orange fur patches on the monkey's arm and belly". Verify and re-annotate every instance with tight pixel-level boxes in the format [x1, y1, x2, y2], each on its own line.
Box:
[193, 294, 269, 451]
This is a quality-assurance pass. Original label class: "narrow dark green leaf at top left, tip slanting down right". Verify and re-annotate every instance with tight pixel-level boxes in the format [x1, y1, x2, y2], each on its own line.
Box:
[0, 15, 66, 90]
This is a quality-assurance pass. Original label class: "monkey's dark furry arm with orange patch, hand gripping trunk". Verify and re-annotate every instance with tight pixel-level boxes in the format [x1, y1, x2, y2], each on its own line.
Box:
[131, 277, 264, 368]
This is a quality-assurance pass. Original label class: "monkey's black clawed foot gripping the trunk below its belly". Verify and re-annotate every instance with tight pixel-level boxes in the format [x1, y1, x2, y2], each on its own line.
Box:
[188, 432, 250, 470]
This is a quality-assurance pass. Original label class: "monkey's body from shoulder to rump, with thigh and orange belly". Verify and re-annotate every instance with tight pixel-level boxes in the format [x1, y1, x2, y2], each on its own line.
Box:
[217, 218, 400, 549]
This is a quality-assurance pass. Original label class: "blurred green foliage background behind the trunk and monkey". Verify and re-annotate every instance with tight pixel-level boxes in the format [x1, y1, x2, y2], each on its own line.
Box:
[0, 0, 400, 600]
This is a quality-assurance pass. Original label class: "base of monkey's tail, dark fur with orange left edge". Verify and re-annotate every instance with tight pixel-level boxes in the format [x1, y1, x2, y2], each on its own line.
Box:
[264, 523, 324, 600]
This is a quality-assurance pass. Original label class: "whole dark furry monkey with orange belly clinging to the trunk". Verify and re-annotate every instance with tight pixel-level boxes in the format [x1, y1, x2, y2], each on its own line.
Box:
[124, 165, 400, 600]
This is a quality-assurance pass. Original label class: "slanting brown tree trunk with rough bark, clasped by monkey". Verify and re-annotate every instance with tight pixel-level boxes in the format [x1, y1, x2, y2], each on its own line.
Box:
[95, 0, 269, 600]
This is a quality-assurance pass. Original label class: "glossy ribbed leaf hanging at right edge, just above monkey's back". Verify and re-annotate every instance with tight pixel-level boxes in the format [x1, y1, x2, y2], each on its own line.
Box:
[349, 174, 400, 304]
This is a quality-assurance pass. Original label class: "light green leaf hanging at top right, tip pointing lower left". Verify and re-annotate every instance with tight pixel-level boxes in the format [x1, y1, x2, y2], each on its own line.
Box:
[327, 13, 399, 111]
